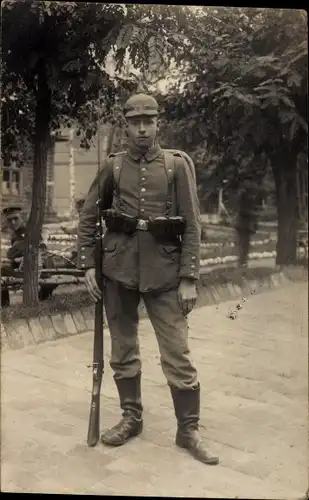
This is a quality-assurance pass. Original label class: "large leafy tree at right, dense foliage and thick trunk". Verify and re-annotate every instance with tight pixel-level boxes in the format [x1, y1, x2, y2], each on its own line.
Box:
[159, 7, 307, 265]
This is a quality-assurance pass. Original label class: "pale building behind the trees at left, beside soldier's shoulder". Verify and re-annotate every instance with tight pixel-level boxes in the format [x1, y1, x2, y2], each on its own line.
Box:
[1, 125, 111, 216]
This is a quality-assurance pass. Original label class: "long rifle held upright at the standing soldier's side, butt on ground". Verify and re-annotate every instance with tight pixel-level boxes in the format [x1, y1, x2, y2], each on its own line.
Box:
[87, 120, 104, 446]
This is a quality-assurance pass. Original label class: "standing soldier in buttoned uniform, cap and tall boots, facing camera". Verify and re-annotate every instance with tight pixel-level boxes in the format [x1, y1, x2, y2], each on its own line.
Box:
[78, 89, 219, 464]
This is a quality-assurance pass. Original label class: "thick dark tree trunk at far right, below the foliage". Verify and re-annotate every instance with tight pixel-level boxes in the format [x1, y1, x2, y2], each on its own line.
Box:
[273, 163, 298, 266]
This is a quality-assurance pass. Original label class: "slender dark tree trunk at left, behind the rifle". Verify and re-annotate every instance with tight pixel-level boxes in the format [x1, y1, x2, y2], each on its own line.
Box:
[23, 60, 51, 306]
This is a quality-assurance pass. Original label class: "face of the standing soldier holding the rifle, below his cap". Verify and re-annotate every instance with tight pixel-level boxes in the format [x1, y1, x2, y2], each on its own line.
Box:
[127, 116, 158, 148]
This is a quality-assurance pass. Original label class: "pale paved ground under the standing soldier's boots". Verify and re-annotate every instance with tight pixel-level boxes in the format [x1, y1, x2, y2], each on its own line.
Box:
[1, 283, 308, 500]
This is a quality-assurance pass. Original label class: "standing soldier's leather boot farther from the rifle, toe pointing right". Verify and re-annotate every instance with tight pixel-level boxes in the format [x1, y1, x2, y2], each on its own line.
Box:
[170, 385, 219, 465]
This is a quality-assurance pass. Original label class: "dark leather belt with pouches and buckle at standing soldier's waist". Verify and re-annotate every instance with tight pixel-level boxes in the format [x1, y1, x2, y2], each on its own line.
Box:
[102, 209, 185, 239]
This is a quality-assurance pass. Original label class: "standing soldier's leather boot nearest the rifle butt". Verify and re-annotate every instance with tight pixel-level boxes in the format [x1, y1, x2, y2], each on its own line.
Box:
[101, 374, 143, 446]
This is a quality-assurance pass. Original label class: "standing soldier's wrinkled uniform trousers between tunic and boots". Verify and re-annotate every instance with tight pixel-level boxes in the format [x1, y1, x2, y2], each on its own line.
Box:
[104, 279, 198, 389]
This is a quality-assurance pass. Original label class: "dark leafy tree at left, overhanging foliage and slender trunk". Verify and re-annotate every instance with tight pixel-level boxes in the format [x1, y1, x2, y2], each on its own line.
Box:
[1, 0, 188, 305]
